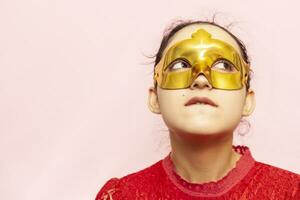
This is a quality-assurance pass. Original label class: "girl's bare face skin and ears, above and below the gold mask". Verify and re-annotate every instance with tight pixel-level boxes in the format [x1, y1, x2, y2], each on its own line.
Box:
[148, 24, 255, 134]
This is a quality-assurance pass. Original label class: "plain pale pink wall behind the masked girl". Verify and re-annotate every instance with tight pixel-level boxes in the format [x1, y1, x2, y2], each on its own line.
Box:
[0, 0, 300, 200]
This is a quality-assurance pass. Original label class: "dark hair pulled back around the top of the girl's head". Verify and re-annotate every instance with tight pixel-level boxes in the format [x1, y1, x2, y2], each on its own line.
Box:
[153, 20, 252, 91]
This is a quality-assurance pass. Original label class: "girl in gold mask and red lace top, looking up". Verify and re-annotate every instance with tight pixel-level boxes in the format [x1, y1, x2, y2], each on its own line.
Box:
[96, 21, 300, 200]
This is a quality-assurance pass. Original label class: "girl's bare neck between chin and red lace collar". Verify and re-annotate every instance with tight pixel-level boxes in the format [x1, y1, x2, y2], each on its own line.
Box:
[170, 131, 241, 183]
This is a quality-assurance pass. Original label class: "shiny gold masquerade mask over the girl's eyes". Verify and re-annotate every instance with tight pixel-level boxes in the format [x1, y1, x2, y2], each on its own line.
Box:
[154, 29, 249, 90]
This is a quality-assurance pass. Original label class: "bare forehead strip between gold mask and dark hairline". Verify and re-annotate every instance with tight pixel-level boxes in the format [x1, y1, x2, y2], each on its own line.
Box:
[164, 24, 241, 55]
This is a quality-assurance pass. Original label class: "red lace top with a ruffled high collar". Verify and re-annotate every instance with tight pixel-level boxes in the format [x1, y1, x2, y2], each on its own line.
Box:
[96, 145, 300, 200]
